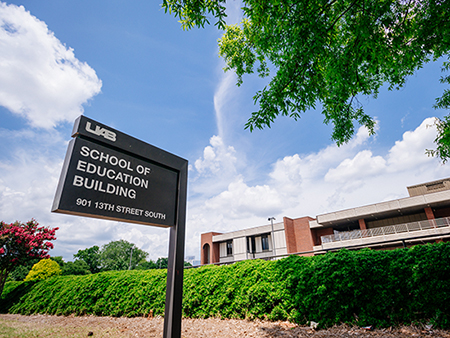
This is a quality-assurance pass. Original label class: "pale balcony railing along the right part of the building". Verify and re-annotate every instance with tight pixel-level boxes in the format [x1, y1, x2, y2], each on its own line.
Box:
[321, 217, 450, 244]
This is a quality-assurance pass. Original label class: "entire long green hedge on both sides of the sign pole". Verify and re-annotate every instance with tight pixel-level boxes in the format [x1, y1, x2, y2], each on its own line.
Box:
[0, 243, 450, 328]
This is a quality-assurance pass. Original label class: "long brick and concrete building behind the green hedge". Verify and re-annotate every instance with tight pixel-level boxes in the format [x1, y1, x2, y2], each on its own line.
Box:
[201, 178, 450, 264]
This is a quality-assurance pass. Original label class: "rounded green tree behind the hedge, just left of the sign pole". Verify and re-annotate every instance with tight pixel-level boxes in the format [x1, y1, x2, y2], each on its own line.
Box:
[100, 239, 148, 270]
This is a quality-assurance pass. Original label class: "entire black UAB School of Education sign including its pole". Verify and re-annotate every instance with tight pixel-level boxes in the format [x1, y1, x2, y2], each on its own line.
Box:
[52, 116, 188, 338]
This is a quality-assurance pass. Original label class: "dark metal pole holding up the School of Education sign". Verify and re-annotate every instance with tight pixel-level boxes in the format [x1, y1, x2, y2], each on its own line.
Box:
[163, 162, 187, 338]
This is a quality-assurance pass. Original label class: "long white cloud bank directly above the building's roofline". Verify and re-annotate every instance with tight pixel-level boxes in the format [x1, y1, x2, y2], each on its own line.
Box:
[188, 119, 450, 245]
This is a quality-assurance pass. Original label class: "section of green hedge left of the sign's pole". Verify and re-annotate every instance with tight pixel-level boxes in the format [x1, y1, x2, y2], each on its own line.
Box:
[0, 270, 167, 317]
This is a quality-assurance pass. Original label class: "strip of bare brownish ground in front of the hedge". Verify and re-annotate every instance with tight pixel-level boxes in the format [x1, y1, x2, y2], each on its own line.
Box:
[0, 314, 450, 338]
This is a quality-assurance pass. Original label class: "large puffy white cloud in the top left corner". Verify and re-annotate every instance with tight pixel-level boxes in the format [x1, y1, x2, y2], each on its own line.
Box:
[0, 2, 102, 128]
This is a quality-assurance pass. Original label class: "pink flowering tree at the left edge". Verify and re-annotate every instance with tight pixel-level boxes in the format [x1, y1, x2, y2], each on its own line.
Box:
[0, 219, 58, 295]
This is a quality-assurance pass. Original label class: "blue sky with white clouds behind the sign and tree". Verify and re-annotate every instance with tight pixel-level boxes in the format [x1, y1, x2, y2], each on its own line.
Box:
[0, 0, 450, 260]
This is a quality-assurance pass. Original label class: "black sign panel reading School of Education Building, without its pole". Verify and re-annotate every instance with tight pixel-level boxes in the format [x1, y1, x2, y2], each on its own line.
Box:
[52, 116, 187, 227]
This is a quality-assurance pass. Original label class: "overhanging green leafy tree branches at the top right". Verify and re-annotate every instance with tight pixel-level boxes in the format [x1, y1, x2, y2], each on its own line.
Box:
[162, 0, 450, 162]
